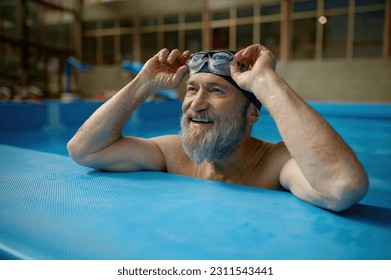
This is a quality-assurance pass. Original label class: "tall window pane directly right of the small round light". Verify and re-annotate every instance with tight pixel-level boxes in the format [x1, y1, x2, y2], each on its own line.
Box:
[323, 15, 348, 58]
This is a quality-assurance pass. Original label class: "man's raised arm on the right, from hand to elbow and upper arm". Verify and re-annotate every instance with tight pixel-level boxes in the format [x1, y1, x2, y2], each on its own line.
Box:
[232, 45, 368, 211]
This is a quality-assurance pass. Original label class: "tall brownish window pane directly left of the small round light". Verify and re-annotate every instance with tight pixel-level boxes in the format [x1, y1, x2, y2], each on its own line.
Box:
[292, 18, 317, 58]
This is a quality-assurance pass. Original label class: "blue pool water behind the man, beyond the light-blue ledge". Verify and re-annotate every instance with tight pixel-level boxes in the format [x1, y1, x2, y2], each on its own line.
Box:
[0, 101, 391, 208]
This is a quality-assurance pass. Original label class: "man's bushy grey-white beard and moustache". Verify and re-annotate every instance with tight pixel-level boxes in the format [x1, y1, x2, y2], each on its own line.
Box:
[180, 106, 248, 164]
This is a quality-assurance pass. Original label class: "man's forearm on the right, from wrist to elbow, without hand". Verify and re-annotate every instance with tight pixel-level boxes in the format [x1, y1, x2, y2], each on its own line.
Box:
[257, 72, 364, 191]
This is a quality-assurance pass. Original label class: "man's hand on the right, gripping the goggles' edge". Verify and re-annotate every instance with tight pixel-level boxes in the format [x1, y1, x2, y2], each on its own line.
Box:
[231, 44, 276, 92]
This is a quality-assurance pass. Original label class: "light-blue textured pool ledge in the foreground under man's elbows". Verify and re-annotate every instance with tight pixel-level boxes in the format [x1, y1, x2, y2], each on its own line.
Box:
[0, 145, 391, 260]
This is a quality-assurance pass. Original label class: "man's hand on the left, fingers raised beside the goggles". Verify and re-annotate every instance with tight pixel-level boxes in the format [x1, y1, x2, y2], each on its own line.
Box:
[139, 49, 191, 92]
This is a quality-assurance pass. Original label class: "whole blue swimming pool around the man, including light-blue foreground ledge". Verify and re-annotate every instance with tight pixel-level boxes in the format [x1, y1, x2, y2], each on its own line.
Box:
[0, 100, 391, 259]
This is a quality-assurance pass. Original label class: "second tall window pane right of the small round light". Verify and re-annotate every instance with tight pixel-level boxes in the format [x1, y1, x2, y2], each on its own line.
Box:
[353, 11, 384, 57]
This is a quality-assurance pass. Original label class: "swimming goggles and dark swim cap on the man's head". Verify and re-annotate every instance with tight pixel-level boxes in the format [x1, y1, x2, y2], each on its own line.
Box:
[187, 50, 262, 110]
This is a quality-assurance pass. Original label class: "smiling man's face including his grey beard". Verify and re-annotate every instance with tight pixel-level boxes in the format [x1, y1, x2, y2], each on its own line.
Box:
[180, 73, 249, 164]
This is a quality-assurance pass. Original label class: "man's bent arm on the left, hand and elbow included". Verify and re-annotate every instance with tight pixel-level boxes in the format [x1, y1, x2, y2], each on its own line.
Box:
[67, 49, 190, 171]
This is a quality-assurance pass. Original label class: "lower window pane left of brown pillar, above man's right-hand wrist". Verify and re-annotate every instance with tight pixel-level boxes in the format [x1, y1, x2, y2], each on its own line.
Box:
[260, 22, 280, 58]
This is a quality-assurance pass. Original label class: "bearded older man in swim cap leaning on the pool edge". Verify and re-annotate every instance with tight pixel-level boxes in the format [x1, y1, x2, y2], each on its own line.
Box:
[68, 44, 368, 211]
